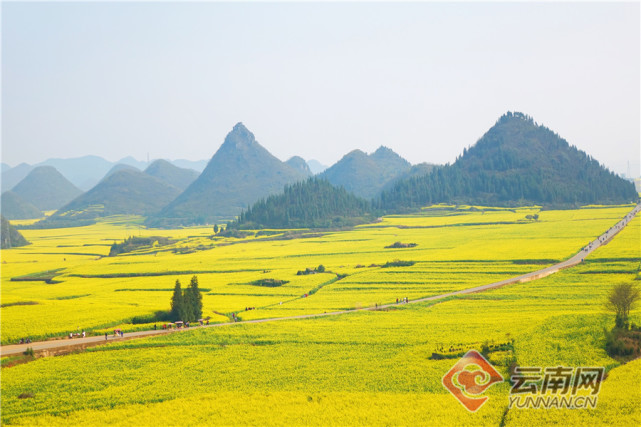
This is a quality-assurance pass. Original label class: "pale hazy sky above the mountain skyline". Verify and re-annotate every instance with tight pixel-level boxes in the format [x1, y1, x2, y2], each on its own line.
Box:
[1, 2, 641, 176]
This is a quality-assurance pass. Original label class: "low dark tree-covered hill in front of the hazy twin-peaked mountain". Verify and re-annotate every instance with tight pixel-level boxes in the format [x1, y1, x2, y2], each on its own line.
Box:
[227, 177, 371, 229]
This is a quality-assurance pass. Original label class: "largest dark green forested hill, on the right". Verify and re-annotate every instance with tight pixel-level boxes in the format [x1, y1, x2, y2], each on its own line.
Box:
[376, 113, 638, 211]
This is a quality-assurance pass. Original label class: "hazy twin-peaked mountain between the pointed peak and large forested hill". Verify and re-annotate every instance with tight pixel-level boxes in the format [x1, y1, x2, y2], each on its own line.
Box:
[319, 147, 411, 199]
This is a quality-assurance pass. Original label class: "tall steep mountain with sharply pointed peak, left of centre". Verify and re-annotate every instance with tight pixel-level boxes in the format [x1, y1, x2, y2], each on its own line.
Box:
[147, 123, 305, 226]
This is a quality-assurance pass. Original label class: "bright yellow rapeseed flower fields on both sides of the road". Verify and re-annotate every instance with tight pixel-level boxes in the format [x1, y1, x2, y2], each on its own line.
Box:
[2, 206, 641, 425]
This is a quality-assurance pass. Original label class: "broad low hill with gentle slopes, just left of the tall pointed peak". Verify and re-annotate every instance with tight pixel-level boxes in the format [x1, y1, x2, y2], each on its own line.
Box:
[45, 166, 180, 224]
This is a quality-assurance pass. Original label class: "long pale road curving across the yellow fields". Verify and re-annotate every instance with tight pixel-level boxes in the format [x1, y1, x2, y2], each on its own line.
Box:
[0, 203, 641, 356]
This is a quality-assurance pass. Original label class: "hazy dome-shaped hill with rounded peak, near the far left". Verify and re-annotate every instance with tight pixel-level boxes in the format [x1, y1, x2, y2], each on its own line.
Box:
[11, 166, 82, 211]
